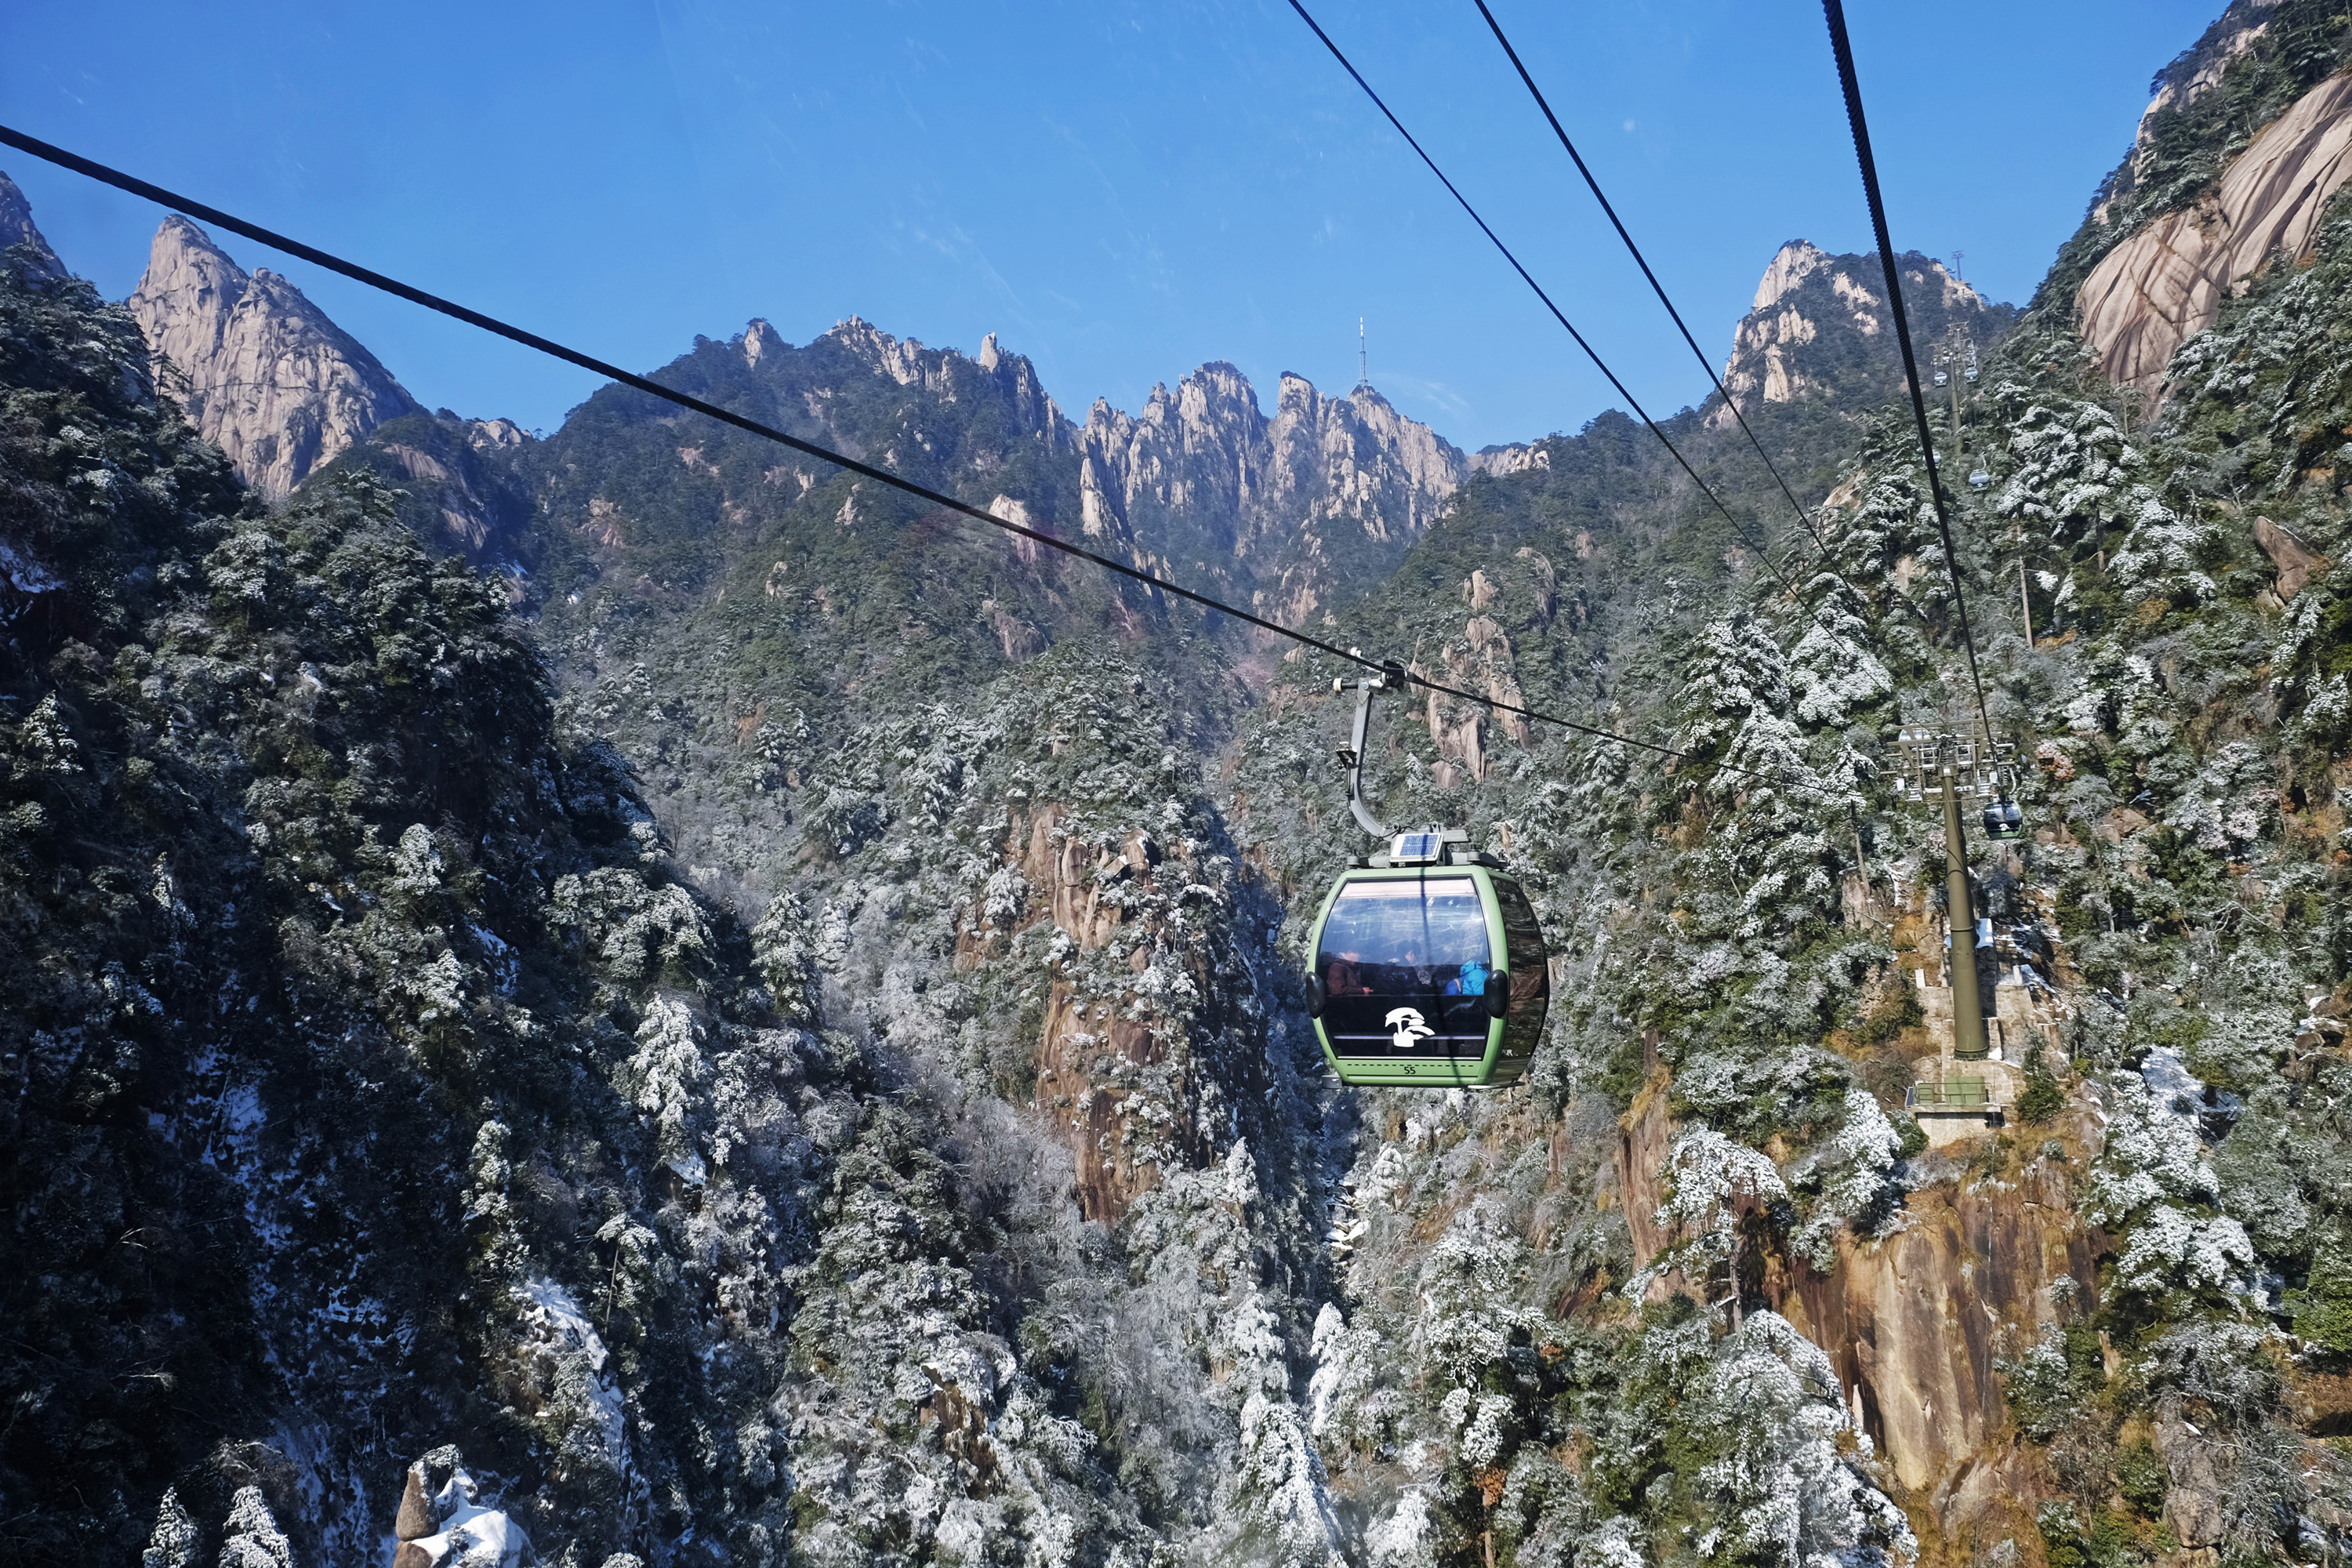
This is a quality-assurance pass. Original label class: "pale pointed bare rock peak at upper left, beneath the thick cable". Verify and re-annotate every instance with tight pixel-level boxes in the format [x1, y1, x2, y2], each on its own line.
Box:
[129, 216, 423, 499]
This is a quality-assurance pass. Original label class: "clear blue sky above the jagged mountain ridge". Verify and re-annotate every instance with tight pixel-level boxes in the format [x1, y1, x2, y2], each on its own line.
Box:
[0, 0, 2223, 449]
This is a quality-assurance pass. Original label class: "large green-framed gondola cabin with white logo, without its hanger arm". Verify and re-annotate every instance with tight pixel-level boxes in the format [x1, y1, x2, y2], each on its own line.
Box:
[1308, 832, 1552, 1088]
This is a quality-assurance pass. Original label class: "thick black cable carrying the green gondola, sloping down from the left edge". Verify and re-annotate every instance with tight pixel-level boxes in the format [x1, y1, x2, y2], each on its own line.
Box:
[0, 125, 1802, 783]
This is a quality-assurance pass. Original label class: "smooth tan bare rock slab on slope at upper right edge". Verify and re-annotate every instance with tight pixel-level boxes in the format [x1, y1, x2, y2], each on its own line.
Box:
[2074, 73, 2352, 402]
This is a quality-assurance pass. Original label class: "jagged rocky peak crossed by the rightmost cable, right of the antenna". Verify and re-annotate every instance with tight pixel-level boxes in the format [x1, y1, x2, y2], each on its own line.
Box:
[1708, 240, 2016, 430]
